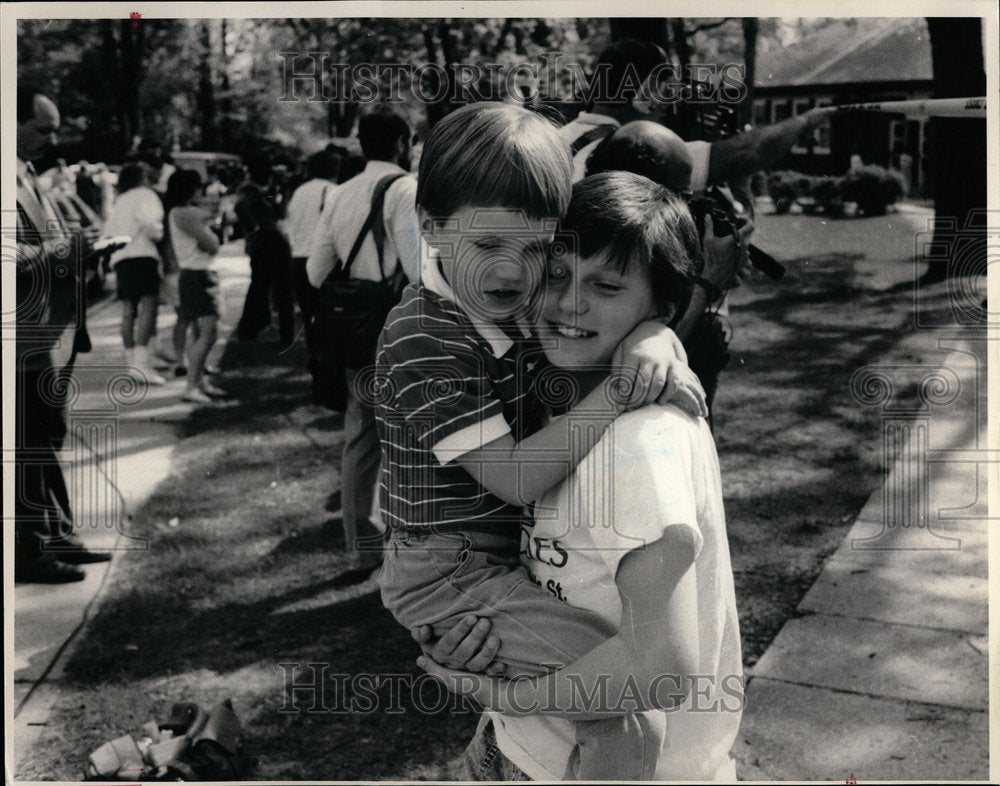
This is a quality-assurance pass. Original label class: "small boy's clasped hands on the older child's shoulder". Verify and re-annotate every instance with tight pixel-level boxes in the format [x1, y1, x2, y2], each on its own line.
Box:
[614, 320, 708, 417]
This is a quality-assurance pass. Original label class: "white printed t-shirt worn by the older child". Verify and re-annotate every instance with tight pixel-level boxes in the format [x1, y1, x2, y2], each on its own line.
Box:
[493, 406, 743, 780]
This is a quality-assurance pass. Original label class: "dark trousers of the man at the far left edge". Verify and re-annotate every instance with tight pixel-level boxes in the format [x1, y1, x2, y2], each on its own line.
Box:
[14, 362, 73, 565]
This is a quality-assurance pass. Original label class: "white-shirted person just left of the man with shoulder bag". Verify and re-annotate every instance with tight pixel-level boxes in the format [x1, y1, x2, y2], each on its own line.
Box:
[285, 150, 340, 355]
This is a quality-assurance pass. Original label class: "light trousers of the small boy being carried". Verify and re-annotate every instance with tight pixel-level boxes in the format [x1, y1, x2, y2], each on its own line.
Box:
[378, 524, 664, 780]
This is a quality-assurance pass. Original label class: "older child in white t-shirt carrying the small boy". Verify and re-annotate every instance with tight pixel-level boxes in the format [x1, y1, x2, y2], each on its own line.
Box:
[421, 172, 743, 780]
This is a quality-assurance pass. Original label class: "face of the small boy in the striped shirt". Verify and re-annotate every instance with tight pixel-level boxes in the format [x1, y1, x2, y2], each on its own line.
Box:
[422, 205, 555, 323]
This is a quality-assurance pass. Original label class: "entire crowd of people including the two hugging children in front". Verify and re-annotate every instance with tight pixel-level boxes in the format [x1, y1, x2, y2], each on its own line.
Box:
[16, 35, 844, 780]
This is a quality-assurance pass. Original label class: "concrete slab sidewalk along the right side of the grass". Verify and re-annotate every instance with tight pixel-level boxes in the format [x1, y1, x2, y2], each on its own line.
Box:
[734, 337, 1000, 782]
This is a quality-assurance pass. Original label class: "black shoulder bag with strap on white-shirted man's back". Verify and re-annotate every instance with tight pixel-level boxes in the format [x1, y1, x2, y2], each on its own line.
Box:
[313, 173, 406, 369]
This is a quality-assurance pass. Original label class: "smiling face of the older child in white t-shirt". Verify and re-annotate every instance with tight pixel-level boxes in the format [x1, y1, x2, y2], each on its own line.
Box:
[538, 251, 656, 369]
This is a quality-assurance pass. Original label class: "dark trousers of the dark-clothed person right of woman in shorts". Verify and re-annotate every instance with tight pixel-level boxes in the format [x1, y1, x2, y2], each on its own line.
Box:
[236, 229, 295, 345]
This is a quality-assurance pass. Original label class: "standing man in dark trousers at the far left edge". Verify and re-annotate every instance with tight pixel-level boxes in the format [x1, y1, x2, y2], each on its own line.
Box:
[14, 85, 111, 583]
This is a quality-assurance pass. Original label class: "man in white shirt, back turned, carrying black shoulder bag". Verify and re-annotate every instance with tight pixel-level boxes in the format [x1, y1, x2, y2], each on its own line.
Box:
[306, 110, 420, 569]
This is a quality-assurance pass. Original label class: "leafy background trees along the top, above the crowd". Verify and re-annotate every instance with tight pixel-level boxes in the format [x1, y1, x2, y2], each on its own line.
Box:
[18, 18, 777, 162]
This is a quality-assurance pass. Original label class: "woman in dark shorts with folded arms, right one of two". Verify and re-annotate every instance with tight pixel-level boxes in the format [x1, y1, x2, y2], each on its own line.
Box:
[166, 169, 225, 404]
